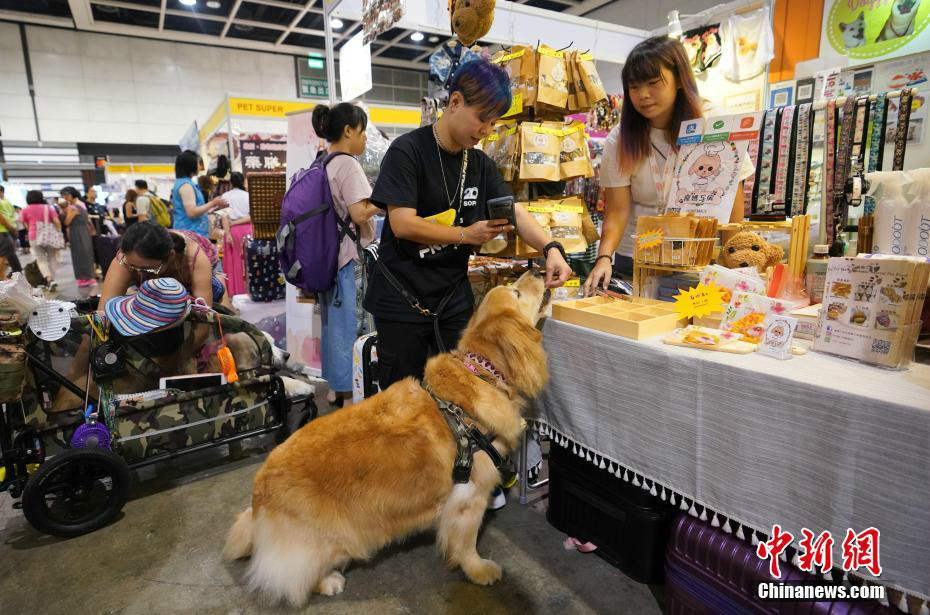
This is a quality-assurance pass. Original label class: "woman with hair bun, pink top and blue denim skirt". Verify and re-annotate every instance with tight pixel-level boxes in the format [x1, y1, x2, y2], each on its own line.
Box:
[312, 103, 380, 406]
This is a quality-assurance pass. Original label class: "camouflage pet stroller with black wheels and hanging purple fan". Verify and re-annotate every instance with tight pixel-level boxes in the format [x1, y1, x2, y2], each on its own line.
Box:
[0, 311, 316, 537]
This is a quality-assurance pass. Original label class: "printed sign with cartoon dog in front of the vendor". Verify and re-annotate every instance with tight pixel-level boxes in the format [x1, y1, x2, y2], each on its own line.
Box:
[666, 113, 761, 224]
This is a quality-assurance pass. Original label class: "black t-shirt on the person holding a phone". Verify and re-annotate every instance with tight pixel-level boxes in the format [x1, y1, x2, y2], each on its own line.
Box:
[364, 126, 511, 323]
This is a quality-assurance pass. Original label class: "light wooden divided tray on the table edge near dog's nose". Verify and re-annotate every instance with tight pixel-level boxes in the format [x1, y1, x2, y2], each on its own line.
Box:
[552, 296, 688, 340]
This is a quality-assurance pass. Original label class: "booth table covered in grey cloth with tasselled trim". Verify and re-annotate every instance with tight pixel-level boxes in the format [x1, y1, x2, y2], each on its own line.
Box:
[527, 319, 930, 600]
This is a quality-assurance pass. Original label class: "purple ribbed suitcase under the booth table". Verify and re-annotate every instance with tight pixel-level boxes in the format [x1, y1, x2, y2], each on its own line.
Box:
[665, 513, 897, 615]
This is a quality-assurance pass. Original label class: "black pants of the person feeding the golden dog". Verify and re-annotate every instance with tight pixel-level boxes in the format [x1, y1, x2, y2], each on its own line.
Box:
[375, 310, 472, 391]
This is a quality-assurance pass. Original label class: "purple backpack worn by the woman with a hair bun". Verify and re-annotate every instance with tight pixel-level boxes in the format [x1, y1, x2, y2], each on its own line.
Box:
[277, 152, 358, 293]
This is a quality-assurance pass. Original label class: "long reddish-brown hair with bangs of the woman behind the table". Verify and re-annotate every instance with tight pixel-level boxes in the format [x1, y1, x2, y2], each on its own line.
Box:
[620, 36, 704, 173]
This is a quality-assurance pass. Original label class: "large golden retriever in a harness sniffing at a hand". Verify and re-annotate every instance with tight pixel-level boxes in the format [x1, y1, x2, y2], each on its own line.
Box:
[223, 272, 549, 606]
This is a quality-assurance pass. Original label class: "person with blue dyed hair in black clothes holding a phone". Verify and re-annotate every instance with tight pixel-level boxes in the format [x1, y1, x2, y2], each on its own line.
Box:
[364, 60, 571, 390]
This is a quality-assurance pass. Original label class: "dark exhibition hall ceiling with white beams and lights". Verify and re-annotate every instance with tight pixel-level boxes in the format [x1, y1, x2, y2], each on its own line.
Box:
[0, 0, 596, 67]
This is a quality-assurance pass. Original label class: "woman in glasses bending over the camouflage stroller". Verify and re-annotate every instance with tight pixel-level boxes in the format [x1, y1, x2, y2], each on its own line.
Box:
[97, 220, 226, 310]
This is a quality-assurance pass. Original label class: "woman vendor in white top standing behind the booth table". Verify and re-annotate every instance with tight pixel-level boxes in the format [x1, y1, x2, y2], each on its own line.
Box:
[585, 36, 755, 294]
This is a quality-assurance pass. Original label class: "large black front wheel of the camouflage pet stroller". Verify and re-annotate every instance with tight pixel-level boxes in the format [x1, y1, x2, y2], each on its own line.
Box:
[23, 448, 131, 538]
